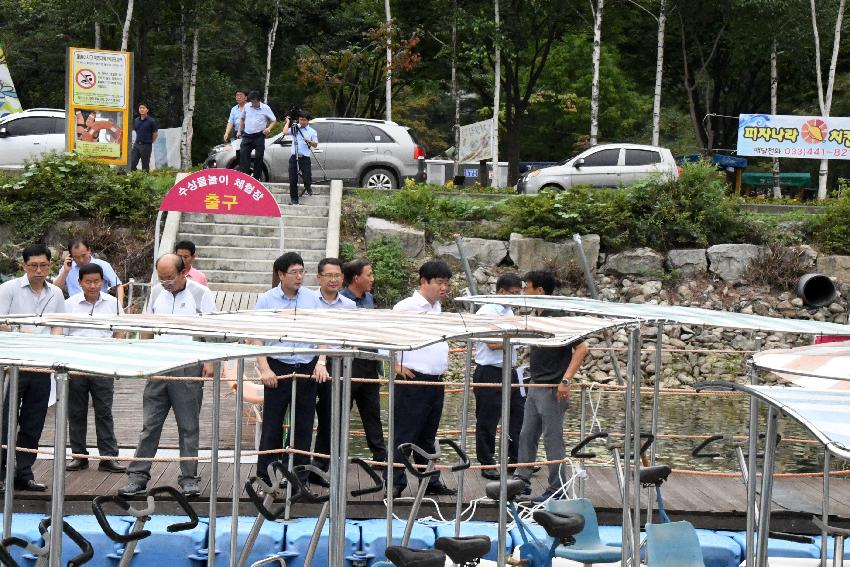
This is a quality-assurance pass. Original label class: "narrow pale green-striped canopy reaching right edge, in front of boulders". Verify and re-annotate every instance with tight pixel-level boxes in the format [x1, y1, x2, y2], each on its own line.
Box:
[455, 295, 850, 336]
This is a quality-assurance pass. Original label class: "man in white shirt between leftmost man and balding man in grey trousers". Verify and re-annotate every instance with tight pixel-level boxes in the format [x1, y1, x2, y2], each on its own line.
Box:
[65, 262, 127, 473]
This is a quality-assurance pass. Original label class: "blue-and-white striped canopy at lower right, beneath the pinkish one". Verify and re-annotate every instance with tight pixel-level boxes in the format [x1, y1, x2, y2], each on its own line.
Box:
[734, 384, 850, 459]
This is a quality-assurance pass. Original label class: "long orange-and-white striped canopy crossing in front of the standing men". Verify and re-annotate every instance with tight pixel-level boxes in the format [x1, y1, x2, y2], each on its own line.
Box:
[0, 309, 637, 350]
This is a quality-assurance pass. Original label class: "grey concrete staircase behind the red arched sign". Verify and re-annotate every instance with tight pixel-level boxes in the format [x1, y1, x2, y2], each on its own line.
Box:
[176, 183, 342, 293]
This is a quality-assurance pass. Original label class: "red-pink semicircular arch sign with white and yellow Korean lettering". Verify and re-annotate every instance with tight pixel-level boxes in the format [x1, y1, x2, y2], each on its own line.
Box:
[159, 169, 280, 217]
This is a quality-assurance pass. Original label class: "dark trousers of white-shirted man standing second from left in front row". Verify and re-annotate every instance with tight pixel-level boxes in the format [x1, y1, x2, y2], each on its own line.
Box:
[68, 376, 118, 457]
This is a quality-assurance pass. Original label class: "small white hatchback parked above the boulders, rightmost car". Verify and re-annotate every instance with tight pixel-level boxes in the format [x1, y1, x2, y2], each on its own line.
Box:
[517, 144, 679, 194]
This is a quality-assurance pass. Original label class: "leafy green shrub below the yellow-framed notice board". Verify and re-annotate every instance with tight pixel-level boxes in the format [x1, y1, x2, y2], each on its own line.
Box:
[0, 154, 167, 240]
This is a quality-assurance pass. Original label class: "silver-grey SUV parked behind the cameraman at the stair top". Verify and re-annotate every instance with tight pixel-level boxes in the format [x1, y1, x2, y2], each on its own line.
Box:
[204, 118, 425, 189]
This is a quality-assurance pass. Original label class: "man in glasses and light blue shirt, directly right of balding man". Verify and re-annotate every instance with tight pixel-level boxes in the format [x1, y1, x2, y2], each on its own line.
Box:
[249, 252, 328, 483]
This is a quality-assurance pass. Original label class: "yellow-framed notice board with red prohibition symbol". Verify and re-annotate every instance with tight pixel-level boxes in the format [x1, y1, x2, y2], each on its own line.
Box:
[65, 47, 133, 165]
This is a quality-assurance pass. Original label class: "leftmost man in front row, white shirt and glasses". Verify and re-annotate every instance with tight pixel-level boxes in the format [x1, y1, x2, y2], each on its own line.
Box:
[0, 244, 65, 492]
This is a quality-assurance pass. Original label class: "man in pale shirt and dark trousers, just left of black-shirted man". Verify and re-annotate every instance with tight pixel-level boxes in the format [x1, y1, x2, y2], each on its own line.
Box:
[472, 272, 525, 480]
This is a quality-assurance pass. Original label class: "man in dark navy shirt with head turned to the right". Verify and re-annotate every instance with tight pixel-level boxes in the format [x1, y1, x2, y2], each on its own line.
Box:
[340, 260, 387, 468]
